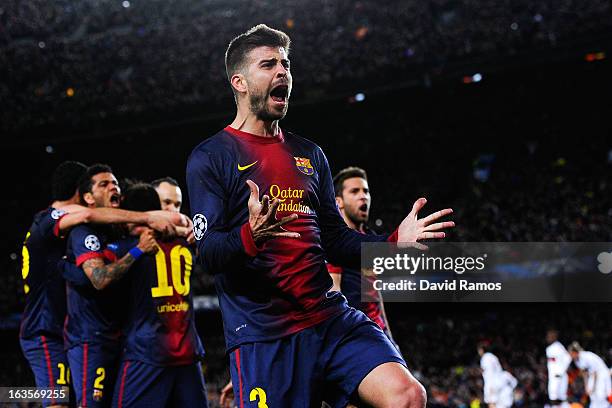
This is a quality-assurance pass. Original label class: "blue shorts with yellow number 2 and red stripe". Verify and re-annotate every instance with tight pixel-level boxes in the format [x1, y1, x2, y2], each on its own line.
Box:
[67, 343, 120, 408]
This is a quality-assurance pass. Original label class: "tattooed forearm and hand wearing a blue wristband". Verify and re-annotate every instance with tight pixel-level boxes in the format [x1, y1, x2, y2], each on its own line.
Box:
[83, 229, 157, 290]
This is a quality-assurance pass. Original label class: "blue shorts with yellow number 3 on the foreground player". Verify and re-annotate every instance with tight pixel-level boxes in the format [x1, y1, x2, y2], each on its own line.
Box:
[230, 308, 406, 408]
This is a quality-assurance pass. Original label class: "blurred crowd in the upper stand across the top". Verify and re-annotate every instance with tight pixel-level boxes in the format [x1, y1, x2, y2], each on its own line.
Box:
[0, 0, 612, 132]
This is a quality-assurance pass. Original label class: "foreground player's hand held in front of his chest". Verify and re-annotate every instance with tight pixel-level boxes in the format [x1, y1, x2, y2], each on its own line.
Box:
[247, 180, 300, 245]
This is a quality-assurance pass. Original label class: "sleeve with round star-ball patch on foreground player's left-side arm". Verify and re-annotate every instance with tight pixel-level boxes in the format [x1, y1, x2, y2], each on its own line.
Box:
[187, 147, 257, 273]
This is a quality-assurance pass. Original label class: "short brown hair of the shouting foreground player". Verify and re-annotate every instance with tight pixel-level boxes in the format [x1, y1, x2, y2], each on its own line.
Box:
[225, 24, 291, 83]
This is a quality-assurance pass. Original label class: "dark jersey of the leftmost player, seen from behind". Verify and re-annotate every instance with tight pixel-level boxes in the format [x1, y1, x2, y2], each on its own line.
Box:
[19, 207, 66, 338]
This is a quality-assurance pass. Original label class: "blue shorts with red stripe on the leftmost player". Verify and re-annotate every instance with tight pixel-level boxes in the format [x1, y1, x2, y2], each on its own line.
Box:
[19, 336, 70, 407]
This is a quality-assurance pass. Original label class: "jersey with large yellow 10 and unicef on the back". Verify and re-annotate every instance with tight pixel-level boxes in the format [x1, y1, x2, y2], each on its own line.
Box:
[115, 238, 204, 366]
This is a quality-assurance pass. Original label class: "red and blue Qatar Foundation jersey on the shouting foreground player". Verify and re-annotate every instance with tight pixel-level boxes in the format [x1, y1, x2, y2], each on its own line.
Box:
[187, 127, 387, 349]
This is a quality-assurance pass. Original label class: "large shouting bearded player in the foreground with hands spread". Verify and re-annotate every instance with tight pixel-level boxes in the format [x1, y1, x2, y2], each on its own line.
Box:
[187, 25, 452, 408]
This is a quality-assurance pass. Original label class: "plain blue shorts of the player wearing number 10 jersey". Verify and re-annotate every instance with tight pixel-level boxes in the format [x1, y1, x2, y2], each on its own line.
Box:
[113, 361, 208, 408]
